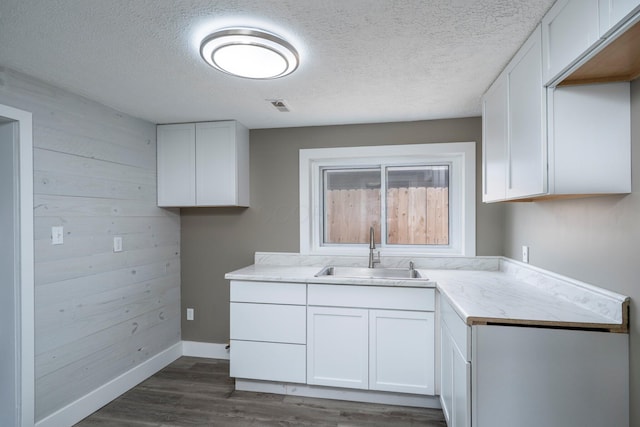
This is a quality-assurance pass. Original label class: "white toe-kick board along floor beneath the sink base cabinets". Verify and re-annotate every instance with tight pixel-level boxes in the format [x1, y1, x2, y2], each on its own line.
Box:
[236, 379, 441, 409]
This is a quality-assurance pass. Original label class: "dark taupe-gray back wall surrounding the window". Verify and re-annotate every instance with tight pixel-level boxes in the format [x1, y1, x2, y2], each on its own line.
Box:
[181, 117, 502, 343]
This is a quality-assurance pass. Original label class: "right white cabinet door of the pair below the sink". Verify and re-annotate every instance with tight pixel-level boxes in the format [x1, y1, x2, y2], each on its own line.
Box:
[369, 310, 435, 395]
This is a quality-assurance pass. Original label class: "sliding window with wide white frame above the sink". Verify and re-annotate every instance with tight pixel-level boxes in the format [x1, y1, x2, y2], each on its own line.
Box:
[300, 143, 475, 256]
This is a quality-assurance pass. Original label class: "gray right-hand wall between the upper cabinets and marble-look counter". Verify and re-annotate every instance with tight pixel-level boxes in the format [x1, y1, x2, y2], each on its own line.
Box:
[504, 80, 640, 426]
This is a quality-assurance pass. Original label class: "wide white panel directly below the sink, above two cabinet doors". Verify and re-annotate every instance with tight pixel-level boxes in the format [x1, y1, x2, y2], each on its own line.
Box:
[308, 285, 435, 311]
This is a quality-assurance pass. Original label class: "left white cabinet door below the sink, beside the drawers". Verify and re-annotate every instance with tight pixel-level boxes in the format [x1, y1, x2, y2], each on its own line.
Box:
[307, 307, 369, 389]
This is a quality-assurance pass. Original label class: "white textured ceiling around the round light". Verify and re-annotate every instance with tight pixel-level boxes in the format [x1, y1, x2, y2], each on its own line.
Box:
[0, 0, 553, 129]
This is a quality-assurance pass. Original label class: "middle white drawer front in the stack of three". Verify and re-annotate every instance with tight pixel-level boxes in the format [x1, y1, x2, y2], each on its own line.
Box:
[230, 302, 307, 344]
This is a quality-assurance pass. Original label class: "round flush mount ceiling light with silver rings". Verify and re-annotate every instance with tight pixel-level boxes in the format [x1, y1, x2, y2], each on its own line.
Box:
[200, 28, 298, 79]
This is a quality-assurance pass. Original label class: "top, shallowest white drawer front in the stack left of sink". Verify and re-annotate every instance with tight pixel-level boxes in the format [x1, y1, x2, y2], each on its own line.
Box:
[230, 280, 307, 305]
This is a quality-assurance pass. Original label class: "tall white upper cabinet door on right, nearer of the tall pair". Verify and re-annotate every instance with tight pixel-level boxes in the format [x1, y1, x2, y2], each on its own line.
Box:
[507, 27, 547, 199]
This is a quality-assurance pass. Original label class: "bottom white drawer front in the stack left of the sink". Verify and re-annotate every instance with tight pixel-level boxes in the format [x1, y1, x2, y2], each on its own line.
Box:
[229, 340, 307, 383]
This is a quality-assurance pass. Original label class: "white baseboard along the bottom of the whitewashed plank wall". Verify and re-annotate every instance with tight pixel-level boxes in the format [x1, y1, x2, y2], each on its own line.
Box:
[36, 342, 182, 427]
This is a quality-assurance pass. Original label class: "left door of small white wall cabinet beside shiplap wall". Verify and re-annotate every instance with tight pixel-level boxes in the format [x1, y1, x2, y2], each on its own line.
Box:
[157, 123, 196, 206]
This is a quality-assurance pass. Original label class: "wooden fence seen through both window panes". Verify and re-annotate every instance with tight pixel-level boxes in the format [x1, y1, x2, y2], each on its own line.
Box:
[326, 187, 449, 245]
